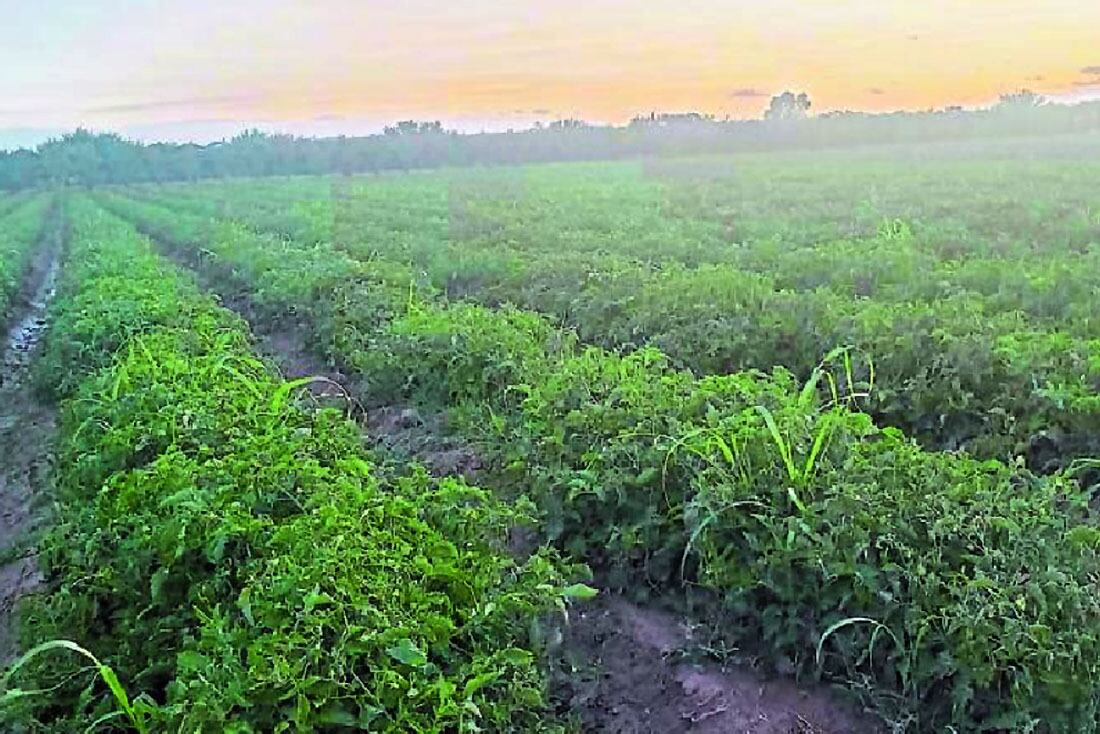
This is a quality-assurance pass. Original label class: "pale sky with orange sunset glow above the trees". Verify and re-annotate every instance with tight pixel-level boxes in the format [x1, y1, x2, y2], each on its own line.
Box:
[0, 0, 1100, 147]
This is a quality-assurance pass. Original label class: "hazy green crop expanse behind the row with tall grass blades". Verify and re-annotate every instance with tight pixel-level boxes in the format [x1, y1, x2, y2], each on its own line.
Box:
[112, 152, 1100, 472]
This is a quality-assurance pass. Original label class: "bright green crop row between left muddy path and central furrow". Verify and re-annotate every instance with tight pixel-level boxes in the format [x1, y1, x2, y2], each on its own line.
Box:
[0, 198, 593, 733]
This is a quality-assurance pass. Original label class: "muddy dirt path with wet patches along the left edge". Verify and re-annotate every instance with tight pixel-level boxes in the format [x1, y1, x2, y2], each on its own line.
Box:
[0, 213, 62, 668]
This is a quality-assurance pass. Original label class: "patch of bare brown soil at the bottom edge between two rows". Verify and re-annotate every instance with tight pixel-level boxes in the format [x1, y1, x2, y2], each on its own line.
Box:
[558, 596, 883, 734]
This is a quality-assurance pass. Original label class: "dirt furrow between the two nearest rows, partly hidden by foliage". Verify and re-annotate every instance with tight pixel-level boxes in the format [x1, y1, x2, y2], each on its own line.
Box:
[146, 224, 882, 734]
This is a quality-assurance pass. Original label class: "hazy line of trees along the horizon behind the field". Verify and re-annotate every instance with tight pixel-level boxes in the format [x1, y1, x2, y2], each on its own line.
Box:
[0, 90, 1100, 190]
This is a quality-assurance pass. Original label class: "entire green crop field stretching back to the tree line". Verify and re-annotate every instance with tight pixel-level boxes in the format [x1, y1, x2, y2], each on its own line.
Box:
[0, 138, 1100, 732]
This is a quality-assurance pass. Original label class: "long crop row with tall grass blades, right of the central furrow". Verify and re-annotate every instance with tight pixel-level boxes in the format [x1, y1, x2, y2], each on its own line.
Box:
[96, 188, 1100, 732]
